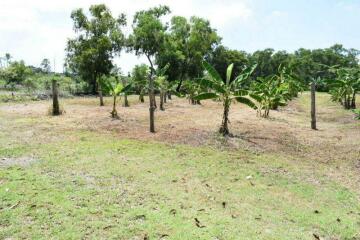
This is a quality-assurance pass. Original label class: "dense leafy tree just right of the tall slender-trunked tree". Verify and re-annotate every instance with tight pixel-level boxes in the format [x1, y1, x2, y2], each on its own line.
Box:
[156, 16, 221, 91]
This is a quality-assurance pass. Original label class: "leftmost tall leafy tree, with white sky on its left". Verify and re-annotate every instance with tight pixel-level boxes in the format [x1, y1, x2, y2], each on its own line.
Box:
[66, 4, 126, 106]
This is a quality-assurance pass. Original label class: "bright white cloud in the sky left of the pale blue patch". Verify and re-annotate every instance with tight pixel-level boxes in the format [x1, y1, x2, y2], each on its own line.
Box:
[0, 0, 253, 71]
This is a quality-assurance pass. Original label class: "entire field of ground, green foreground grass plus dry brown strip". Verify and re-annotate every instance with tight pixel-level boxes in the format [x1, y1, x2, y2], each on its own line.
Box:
[0, 93, 360, 240]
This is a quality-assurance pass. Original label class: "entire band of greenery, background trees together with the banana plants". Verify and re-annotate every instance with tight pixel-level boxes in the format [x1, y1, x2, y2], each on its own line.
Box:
[0, 4, 360, 131]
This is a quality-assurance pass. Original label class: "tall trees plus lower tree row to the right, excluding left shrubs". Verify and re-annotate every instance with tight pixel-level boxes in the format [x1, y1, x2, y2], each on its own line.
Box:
[62, 5, 359, 93]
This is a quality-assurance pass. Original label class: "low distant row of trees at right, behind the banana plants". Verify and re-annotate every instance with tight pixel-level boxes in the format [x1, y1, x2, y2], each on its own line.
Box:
[208, 44, 360, 91]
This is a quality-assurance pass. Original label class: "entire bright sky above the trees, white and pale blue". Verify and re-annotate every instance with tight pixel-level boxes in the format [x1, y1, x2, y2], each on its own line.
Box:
[0, 0, 360, 73]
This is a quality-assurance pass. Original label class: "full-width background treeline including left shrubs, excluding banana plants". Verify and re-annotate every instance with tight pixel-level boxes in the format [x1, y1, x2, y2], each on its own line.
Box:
[0, 4, 360, 112]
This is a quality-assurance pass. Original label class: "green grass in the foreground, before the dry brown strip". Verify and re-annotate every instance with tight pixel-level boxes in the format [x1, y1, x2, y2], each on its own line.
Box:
[0, 129, 360, 239]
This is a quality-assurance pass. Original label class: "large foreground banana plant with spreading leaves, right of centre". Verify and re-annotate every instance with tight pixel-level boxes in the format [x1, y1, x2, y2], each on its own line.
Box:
[194, 62, 256, 136]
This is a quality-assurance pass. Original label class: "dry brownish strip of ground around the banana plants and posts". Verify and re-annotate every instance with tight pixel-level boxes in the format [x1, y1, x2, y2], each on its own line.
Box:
[0, 93, 360, 187]
